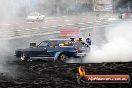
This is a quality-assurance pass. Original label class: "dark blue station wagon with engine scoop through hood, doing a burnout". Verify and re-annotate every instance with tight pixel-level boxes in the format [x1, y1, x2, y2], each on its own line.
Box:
[15, 39, 90, 62]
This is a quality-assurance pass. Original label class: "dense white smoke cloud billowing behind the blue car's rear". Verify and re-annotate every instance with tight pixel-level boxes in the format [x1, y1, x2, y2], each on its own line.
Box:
[84, 21, 132, 63]
